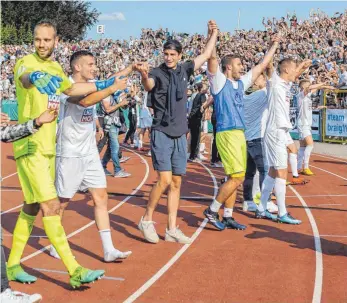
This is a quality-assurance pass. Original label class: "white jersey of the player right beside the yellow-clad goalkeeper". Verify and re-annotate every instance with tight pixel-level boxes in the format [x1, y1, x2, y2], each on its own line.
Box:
[56, 77, 98, 158]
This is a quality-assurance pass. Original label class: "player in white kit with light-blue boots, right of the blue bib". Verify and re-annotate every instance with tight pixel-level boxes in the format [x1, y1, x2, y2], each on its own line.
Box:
[255, 59, 312, 224]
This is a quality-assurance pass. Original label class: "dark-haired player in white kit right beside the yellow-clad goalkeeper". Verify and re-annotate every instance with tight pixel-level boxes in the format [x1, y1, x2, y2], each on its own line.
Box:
[50, 50, 131, 262]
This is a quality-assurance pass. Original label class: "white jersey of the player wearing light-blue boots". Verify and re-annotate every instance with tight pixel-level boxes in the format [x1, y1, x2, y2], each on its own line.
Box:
[266, 72, 292, 133]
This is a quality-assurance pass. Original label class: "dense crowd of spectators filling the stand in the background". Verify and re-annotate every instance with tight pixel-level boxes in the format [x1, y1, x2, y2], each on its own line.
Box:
[0, 10, 347, 106]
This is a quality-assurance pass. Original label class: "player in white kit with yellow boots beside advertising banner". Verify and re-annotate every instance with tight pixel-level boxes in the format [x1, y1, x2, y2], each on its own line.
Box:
[297, 80, 335, 176]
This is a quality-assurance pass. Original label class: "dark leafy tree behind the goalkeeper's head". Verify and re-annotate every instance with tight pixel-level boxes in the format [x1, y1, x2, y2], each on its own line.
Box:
[1, 0, 100, 42]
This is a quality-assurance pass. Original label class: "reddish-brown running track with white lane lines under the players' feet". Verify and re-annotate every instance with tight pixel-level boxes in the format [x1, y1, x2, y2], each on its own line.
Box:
[1, 138, 347, 303]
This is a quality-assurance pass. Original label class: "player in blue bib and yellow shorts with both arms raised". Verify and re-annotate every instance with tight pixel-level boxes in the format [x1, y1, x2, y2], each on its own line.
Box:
[204, 35, 279, 230]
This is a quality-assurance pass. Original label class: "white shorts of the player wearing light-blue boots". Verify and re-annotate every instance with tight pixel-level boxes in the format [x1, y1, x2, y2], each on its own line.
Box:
[264, 129, 290, 169]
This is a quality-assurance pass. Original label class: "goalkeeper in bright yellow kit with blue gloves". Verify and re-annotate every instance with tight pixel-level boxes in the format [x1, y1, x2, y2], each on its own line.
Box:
[7, 21, 119, 287]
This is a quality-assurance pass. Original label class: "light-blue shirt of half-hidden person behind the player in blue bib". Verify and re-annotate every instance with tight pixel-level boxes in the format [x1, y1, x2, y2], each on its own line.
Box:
[243, 87, 269, 141]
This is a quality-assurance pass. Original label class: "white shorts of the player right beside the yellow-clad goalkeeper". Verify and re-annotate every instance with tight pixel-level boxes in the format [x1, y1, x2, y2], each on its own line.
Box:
[55, 153, 107, 199]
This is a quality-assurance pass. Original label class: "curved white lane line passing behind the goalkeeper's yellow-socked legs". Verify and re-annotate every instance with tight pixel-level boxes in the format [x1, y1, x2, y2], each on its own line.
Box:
[21, 150, 149, 262]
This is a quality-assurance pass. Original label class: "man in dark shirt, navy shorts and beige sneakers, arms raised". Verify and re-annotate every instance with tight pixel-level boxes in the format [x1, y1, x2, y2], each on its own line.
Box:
[139, 21, 218, 244]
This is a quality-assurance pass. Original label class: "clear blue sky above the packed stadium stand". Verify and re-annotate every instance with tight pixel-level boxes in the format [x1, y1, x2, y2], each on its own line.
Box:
[87, 1, 347, 39]
